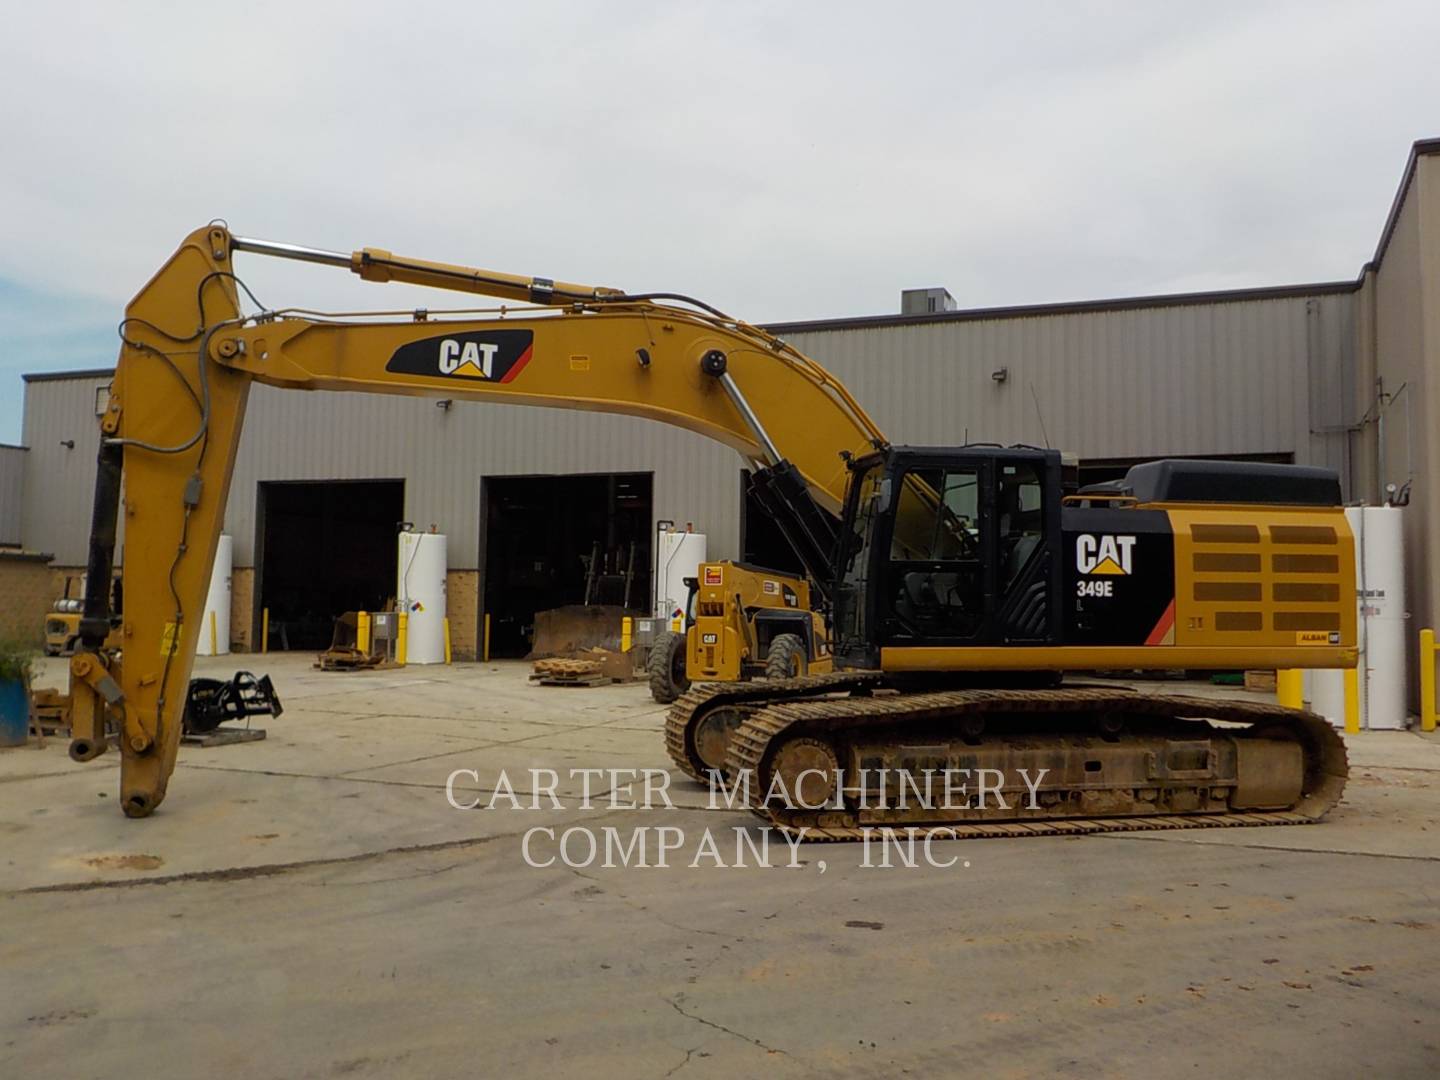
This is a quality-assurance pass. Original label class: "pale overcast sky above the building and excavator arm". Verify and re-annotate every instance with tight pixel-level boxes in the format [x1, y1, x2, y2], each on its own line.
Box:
[0, 0, 1440, 442]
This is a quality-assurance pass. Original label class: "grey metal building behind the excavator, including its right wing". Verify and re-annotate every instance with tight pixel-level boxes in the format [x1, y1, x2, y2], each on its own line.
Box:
[11, 140, 1440, 694]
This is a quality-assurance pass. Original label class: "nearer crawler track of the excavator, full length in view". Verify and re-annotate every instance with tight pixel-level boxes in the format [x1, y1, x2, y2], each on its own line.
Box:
[726, 687, 1348, 841]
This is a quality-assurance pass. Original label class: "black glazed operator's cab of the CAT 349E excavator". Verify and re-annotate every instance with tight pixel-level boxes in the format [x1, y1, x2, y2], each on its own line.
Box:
[835, 446, 1061, 668]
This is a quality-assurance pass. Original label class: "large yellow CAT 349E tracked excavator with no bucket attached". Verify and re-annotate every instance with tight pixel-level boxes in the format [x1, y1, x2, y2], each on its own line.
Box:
[71, 225, 1356, 840]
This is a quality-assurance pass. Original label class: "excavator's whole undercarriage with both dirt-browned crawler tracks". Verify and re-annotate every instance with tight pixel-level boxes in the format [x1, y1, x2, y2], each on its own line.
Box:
[665, 672, 1348, 840]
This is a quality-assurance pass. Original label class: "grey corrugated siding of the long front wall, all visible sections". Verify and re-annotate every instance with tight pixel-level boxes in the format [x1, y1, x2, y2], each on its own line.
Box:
[24, 294, 1354, 569]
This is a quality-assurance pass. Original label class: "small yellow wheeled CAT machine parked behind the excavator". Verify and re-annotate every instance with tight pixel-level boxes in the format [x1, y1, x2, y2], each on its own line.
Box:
[648, 562, 832, 704]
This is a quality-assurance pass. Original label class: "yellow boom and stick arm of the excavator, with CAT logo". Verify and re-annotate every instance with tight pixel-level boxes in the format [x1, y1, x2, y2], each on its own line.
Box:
[71, 226, 884, 816]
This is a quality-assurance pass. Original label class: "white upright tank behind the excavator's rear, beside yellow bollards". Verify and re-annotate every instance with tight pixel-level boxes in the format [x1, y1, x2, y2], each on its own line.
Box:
[1310, 507, 1407, 730]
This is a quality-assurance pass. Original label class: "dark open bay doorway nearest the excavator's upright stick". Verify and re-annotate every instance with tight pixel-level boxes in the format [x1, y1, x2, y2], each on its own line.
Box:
[255, 480, 405, 649]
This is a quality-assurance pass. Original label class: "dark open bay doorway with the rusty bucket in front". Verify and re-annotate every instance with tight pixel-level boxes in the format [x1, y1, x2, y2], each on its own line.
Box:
[480, 472, 654, 657]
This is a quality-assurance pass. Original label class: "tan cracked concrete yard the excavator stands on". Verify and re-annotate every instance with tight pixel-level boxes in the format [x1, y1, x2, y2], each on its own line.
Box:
[0, 655, 1440, 1080]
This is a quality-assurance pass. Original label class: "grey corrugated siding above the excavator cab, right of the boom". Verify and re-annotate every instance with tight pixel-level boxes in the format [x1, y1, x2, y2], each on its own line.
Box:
[788, 295, 1354, 464]
